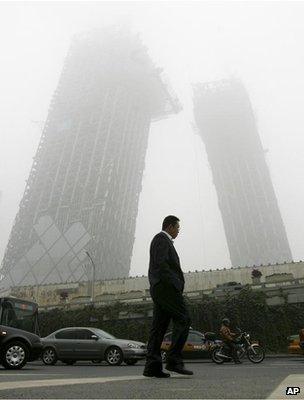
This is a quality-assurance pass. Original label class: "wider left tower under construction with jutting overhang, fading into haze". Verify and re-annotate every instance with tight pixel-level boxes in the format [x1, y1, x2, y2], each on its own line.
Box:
[0, 29, 179, 287]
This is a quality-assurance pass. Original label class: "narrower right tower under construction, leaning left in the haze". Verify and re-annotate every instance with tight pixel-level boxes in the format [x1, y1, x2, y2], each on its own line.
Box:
[194, 80, 292, 266]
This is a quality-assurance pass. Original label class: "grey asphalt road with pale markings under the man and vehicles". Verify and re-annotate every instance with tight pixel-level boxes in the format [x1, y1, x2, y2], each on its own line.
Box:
[0, 357, 304, 399]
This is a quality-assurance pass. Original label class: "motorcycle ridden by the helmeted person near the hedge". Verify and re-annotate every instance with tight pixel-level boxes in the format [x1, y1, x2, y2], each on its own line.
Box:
[211, 332, 265, 364]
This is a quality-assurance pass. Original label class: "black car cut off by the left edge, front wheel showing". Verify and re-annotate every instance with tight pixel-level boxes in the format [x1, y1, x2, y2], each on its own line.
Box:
[0, 325, 42, 369]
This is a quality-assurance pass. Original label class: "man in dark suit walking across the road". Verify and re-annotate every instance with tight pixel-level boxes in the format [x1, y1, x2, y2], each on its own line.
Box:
[143, 215, 193, 378]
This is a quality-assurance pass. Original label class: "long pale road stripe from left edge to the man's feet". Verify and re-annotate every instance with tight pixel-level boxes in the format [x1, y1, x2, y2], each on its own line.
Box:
[0, 375, 150, 390]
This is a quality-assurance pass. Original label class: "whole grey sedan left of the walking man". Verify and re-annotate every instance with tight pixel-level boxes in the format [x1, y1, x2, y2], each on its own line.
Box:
[41, 327, 147, 365]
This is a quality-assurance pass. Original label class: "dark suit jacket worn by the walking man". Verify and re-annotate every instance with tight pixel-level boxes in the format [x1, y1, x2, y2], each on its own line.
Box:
[148, 232, 185, 292]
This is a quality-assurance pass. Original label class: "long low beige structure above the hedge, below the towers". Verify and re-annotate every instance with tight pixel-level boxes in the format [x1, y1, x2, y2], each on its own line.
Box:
[1, 261, 304, 308]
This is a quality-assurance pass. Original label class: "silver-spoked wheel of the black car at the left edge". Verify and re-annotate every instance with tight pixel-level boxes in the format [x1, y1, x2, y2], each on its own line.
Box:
[2, 340, 28, 369]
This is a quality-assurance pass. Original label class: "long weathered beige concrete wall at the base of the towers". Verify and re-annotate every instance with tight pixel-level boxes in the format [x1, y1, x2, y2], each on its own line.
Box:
[8, 262, 304, 306]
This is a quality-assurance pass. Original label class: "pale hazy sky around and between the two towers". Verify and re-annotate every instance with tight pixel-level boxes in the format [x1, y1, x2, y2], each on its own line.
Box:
[0, 1, 304, 275]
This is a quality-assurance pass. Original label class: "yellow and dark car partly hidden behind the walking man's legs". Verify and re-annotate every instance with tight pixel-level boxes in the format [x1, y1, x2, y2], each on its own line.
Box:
[161, 329, 222, 362]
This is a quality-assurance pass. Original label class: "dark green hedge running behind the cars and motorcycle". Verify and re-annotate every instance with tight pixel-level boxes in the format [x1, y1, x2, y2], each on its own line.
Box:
[39, 288, 304, 352]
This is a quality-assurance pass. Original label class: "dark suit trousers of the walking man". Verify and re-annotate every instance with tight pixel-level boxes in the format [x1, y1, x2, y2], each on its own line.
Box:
[145, 282, 190, 371]
